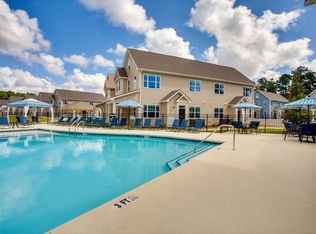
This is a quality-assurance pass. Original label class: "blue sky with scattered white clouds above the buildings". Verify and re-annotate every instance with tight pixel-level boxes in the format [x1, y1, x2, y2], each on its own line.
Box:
[0, 0, 316, 93]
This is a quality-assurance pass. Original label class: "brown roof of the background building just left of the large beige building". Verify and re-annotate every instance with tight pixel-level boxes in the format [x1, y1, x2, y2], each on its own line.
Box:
[54, 89, 105, 102]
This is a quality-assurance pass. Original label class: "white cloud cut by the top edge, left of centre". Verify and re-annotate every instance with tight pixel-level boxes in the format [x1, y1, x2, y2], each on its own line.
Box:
[79, 0, 155, 33]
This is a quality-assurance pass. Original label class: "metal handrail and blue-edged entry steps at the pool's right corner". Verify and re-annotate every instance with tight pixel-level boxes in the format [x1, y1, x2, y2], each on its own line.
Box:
[166, 124, 236, 170]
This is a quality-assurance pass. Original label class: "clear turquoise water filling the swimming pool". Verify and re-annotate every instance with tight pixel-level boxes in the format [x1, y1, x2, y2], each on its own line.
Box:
[0, 131, 215, 234]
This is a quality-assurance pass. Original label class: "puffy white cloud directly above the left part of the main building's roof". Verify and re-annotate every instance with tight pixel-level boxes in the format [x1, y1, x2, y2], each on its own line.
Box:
[144, 28, 194, 59]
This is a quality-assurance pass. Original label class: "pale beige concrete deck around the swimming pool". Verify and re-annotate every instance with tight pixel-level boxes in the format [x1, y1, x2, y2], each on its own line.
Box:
[0, 125, 316, 234]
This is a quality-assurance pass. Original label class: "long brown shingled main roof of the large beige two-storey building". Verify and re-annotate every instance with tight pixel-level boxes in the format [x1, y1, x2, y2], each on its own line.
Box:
[127, 48, 255, 86]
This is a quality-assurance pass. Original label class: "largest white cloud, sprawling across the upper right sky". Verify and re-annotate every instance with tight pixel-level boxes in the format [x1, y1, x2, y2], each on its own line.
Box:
[187, 0, 313, 78]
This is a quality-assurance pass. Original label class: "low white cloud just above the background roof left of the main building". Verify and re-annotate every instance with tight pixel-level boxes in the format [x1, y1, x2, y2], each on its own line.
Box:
[63, 68, 106, 93]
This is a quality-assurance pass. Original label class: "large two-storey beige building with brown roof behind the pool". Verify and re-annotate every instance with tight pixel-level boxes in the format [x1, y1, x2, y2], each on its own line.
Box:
[99, 49, 255, 123]
